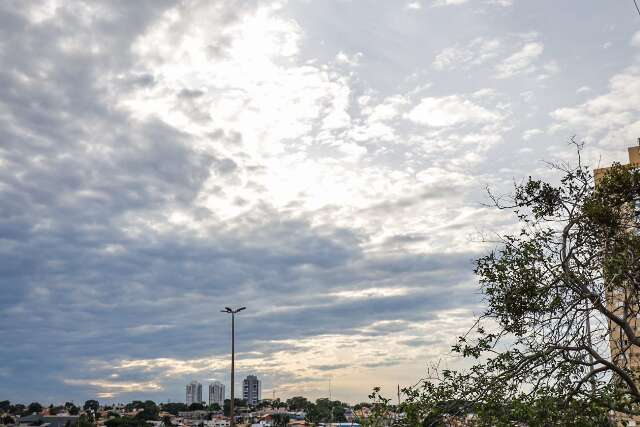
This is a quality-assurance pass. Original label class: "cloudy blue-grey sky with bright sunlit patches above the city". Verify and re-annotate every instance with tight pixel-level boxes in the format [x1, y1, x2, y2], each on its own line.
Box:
[0, 0, 640, 403]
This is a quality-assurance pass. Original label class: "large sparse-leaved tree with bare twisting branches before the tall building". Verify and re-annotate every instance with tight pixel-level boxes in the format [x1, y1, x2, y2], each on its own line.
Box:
[405, 150, 640, 426]
